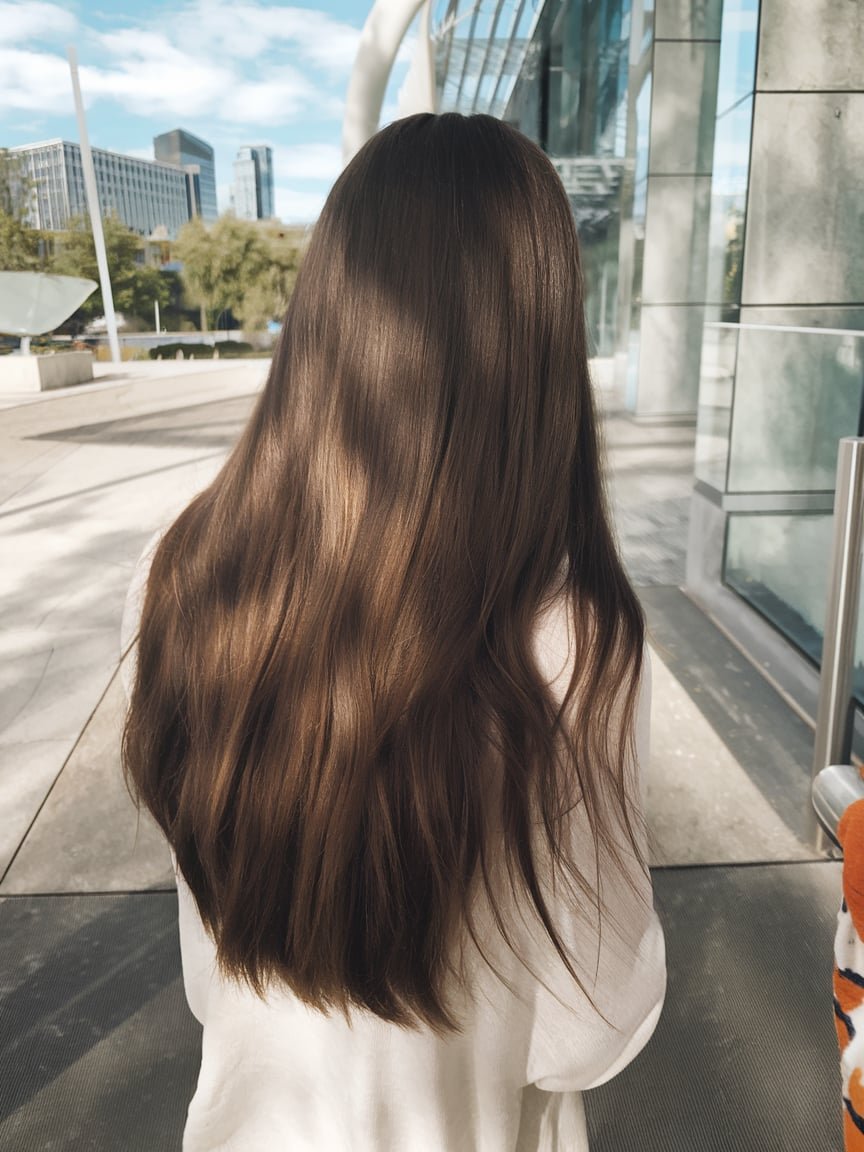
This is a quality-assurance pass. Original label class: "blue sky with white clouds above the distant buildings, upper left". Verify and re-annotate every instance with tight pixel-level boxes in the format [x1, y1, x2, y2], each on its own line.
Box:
[0, 0, 419, 222]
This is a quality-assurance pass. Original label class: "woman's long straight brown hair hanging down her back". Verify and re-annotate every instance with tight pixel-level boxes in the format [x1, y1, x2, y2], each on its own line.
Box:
[123, 114, 643, 1032]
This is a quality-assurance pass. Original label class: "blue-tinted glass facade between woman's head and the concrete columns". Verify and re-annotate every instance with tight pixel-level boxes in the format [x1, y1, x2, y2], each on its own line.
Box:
[437, 0, 630, 355]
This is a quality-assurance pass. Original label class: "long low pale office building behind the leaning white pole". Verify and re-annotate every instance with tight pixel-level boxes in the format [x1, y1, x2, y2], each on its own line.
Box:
[10, 139, 189, 238]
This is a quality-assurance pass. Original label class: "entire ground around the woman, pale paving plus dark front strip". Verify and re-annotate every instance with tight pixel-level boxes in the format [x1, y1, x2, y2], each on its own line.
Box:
[0, 363, 842, 1152]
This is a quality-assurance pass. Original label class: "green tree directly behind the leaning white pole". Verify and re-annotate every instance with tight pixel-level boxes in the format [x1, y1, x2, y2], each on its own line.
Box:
[52, 217, 172, 331]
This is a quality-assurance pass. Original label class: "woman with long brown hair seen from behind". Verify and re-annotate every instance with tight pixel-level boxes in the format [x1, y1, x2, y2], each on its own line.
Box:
[124, 114, 665, 1152]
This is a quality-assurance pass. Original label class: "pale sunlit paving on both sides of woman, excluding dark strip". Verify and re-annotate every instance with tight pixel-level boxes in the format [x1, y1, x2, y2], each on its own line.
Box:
[0, 362, 814, 895]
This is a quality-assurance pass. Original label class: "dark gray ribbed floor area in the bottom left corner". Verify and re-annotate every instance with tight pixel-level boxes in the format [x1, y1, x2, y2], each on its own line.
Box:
[0, 893, 200, 1152]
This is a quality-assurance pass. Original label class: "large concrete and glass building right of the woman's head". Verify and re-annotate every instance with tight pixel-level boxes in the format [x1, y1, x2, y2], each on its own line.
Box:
[432, 0, 864, 748]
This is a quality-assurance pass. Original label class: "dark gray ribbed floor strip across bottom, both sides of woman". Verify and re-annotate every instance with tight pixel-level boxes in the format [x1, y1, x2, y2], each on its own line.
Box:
[0, 864, 842, 1152]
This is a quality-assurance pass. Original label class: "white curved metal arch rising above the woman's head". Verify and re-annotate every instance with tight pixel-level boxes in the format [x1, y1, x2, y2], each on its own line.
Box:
[342, 0, 435, 164]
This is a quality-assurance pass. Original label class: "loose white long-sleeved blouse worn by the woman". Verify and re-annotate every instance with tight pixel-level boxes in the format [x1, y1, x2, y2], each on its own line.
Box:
[123, 541, 666, 1152]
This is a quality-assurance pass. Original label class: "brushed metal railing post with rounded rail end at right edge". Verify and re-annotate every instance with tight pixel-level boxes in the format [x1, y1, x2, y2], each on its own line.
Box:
[811, 437, 864, 850]
